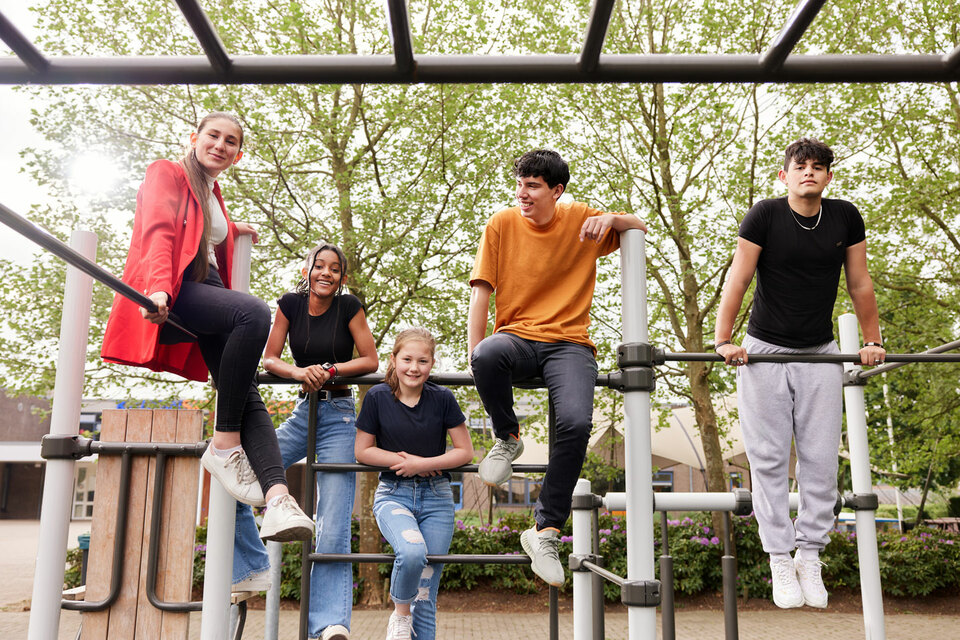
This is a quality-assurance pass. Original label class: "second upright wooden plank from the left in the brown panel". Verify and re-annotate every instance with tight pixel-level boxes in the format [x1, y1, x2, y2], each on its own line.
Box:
[107, 409, 153, 640]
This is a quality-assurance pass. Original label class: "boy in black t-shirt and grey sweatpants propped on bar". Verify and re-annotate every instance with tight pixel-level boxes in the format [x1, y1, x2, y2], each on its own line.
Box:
[714, 138, 886, 608]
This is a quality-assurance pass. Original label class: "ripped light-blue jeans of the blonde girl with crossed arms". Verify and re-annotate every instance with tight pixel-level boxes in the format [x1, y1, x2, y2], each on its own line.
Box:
[373, 476, 453, 640]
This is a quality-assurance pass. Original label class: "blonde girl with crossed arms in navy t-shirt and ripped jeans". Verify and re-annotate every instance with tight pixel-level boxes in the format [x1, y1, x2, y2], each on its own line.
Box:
[355, 328, 473, 640]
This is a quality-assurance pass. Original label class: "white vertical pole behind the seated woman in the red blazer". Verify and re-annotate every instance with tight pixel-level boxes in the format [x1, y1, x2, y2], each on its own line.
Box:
[200, 236, 253, 640]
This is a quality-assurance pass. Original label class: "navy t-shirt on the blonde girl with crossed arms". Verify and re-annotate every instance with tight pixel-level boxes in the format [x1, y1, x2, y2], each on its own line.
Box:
[357, 382, 467, 480]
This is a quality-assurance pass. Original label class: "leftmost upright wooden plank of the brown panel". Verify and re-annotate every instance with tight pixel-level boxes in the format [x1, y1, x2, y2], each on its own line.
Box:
[82, 409, 127, 640]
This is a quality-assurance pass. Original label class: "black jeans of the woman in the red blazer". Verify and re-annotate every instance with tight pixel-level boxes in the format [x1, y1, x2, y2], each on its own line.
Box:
[171, 267, 287, 493]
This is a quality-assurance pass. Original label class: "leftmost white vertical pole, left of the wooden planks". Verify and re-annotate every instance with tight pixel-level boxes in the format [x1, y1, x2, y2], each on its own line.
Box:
[27, 230, 97, 640]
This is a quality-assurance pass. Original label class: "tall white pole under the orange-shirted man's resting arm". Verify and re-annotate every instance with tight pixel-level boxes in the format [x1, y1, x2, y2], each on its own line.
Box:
[620, 229, 657, 640]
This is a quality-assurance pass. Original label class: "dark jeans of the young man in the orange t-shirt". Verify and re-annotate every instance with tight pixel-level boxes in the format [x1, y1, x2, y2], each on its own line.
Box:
[471, 331, 597, 529]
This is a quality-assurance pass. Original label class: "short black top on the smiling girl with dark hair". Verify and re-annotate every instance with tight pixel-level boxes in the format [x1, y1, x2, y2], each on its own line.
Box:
[277, 293, 363, 367]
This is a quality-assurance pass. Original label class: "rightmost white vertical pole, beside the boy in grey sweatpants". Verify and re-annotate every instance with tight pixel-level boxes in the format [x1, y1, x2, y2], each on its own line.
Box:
[839, 313, 887, 640]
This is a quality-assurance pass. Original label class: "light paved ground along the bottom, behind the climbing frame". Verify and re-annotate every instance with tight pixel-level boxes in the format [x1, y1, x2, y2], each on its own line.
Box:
[0, 520, 960, 640]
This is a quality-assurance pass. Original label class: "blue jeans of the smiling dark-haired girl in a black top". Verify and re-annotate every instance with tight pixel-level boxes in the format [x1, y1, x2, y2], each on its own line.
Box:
[233, 398, 357, 637]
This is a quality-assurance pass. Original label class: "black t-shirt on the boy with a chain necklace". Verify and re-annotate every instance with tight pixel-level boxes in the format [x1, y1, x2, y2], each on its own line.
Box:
[740, 198, 866, 348]
